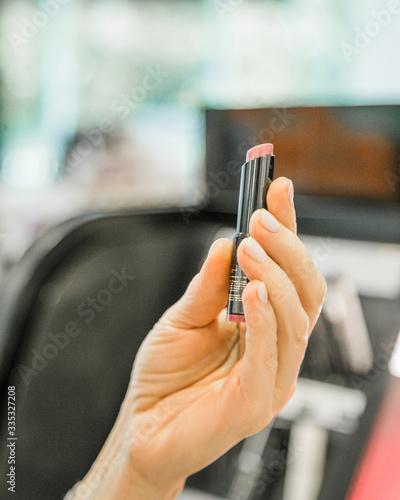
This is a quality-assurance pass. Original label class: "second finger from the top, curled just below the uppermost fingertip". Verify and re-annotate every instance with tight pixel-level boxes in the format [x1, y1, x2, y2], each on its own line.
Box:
[250, 210, 326, 329]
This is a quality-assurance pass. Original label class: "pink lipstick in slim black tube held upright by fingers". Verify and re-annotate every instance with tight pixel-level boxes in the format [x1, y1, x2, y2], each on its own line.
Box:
[227, 143, 275, 323]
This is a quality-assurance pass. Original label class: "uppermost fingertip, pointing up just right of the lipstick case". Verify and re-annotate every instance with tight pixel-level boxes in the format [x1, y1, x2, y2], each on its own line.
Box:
[267, 177, 297, 234]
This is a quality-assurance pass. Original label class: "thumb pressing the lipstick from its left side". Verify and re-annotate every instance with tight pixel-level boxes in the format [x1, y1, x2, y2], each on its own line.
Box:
[161, 238, 232, 328]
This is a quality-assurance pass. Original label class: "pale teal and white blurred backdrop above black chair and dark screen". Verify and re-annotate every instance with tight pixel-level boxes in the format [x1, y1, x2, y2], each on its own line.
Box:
[0, 0, 400, 262]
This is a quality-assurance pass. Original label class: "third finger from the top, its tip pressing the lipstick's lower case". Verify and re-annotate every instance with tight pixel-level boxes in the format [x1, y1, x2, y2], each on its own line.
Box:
[238, 237, 309, 411]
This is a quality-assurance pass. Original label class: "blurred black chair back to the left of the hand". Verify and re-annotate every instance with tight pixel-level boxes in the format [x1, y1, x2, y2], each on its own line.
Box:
[0, 210, 225, 500]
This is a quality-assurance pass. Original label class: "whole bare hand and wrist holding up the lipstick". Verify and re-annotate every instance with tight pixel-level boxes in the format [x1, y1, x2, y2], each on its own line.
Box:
[73, 177, 326, 500]
